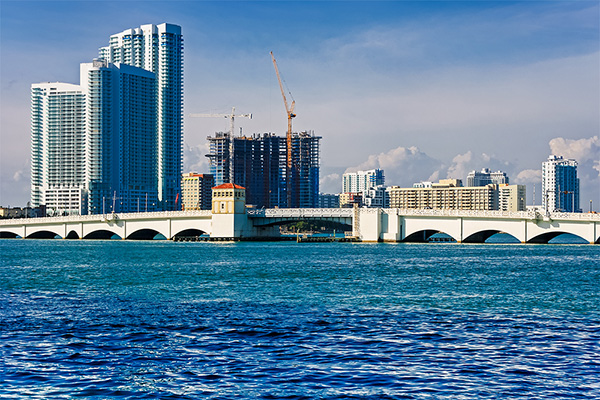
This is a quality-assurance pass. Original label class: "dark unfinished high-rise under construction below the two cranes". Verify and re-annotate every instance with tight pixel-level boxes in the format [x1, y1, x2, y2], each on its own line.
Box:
[207, 132, 321, 208]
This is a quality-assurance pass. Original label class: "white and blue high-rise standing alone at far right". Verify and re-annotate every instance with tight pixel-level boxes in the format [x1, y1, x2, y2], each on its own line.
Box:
[542, 155, 581, 212]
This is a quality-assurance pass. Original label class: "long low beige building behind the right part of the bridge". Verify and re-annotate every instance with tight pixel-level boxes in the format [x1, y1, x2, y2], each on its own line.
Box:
[388, 180, 525, 211]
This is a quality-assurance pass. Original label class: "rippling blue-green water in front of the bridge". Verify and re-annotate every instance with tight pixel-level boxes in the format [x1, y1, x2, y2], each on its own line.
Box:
[0, 240, 600, 399]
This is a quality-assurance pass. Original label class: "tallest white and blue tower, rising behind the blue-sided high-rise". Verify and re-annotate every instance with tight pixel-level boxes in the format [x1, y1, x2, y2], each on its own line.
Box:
[99, 23, 183, 210]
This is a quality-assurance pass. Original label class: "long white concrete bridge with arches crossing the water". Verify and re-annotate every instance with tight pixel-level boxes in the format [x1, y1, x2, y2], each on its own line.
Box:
[0, 208, 600, 244]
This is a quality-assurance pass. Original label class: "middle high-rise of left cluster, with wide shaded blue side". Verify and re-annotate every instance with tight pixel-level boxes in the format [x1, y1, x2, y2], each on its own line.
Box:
[80, 60, 158, 214]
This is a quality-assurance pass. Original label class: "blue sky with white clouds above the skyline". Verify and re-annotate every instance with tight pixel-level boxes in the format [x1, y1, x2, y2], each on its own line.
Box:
[0, 0, 600, 211]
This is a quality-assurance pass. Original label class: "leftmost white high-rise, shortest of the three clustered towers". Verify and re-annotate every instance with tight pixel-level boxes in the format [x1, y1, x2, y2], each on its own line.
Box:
[31, 82, 87, 215]
